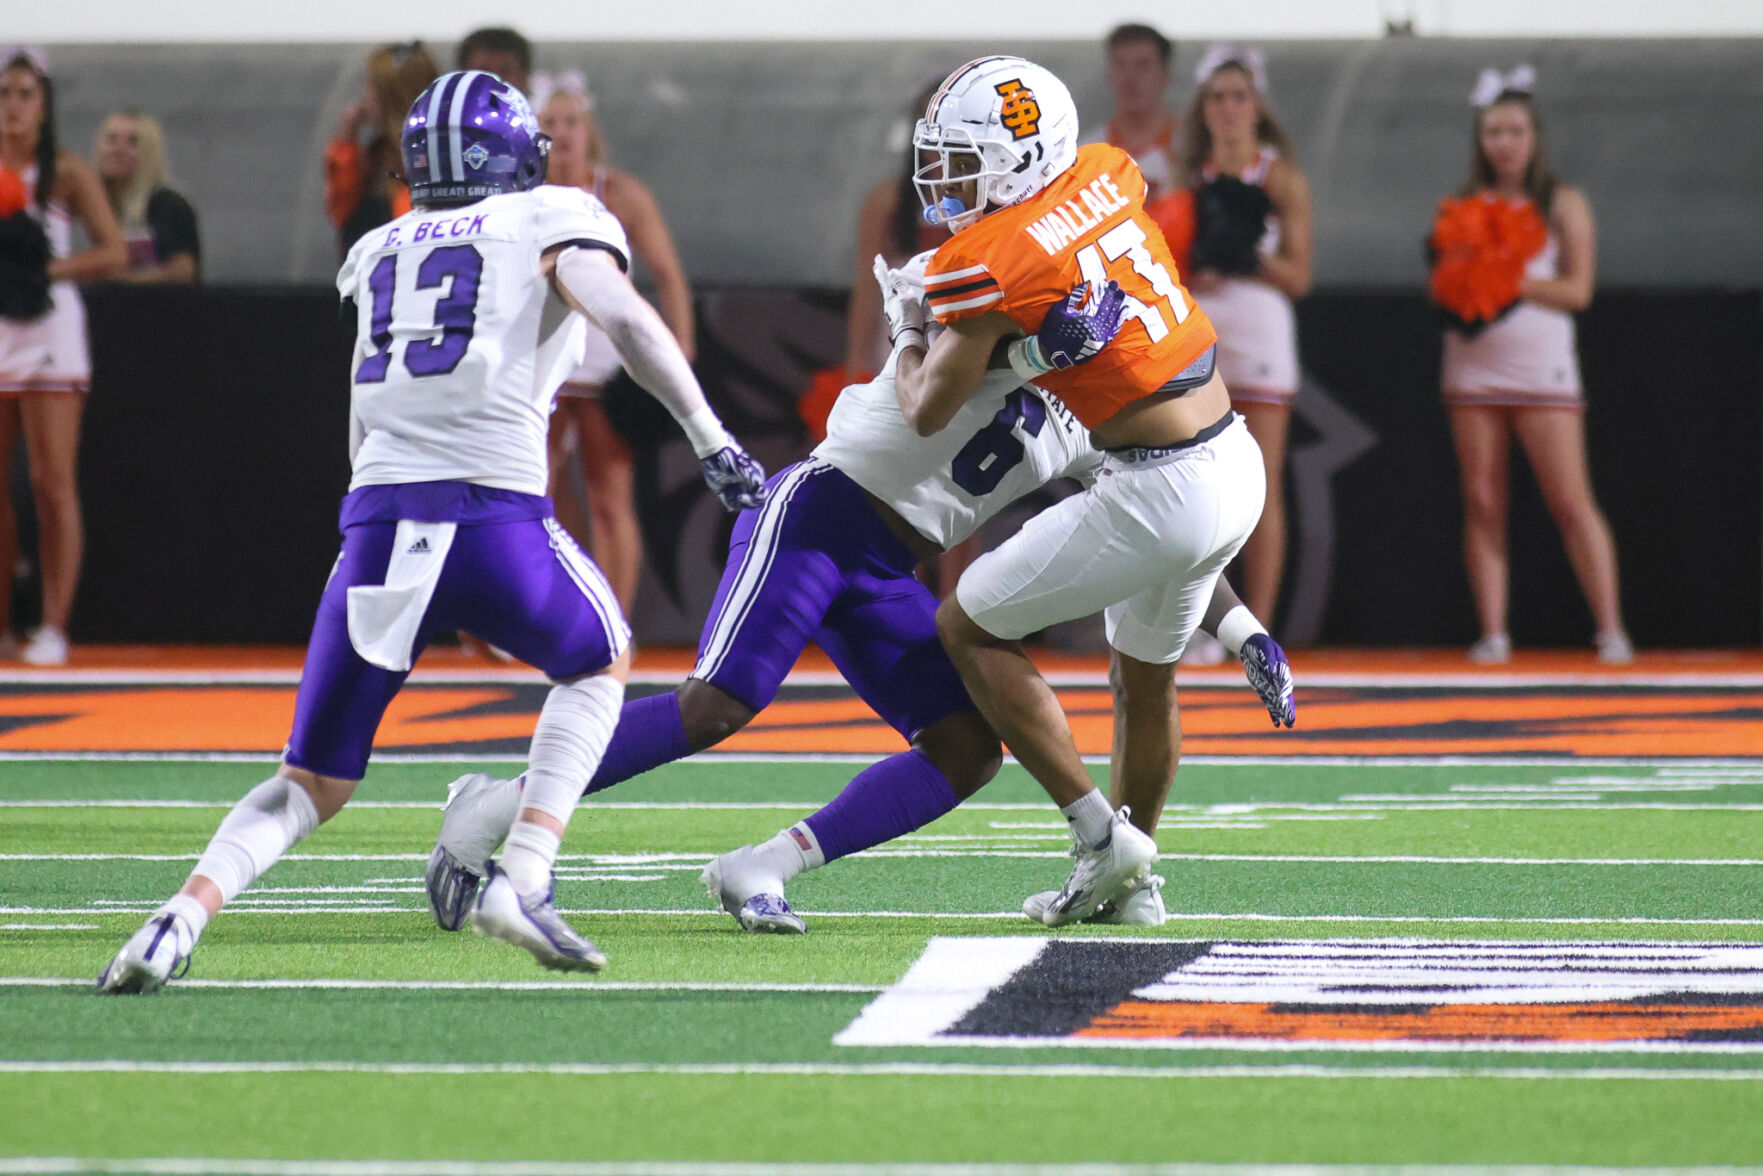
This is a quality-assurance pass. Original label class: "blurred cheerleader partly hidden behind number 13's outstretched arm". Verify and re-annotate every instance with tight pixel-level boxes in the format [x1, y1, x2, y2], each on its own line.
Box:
[532, 71, 696, 614]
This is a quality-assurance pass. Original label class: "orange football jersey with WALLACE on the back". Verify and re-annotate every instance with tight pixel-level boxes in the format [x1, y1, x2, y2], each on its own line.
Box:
[924, 143, 1218, 428]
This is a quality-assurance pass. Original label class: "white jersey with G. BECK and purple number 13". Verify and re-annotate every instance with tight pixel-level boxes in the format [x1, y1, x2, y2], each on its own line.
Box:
[337, 187, 629, 494]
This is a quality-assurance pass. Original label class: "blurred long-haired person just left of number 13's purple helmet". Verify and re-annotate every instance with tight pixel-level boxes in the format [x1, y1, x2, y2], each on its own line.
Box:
[324, 41, 439, 256]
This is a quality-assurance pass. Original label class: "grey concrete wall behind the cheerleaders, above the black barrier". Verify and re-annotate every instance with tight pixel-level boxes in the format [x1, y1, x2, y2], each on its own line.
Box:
[49, 39, 1763, 287]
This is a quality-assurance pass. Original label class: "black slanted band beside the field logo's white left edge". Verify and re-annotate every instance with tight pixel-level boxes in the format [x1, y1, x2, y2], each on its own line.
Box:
[945, 940, 1211, 1037]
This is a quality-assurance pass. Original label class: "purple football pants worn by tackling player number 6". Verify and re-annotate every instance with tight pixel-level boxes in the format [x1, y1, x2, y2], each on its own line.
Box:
[691, 457, 973, 741]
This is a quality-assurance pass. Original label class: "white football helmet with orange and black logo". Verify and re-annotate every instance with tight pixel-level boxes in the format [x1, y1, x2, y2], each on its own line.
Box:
[911, 56, 1077, 233]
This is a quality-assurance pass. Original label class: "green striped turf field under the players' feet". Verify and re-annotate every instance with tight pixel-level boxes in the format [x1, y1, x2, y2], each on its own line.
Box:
[0, 760, 1763, 1172]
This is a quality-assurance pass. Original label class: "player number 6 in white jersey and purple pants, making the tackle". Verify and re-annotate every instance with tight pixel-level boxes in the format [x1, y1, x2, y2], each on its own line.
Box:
[427, 259, 1292, 933]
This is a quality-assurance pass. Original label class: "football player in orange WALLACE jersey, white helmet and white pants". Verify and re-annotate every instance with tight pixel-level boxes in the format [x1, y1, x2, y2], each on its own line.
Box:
[885, 56, 1292, 926]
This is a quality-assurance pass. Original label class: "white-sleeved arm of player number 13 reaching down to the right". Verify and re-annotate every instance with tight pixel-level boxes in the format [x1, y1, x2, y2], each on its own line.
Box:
[543, 245, 730, 457]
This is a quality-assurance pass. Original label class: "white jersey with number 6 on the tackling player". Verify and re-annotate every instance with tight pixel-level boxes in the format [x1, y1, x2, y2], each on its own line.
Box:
[815, 358, 1102, 548]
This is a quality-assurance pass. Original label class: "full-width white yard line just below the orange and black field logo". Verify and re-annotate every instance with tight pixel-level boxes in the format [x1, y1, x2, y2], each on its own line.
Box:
[0, 1064, 1763, 1083]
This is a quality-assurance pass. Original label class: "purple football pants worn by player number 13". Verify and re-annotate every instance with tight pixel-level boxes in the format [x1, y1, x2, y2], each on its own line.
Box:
[286, 481, 631, 779]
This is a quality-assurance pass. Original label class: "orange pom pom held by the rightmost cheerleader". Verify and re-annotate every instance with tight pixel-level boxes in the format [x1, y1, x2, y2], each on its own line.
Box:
[1426, 196, 1548, 337]
